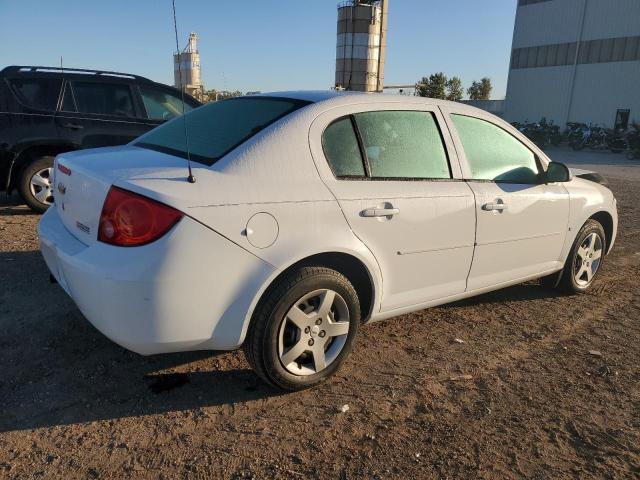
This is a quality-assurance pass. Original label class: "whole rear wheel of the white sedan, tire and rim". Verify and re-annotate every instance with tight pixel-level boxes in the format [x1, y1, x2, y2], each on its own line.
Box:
[244, 267, 360, 391]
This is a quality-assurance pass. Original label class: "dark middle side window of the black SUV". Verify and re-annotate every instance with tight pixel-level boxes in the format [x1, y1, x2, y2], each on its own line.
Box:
[72, 82, 135, 117]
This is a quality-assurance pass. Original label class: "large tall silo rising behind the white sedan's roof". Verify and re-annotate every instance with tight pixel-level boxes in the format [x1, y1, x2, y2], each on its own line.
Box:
[335, 0, 389, 92]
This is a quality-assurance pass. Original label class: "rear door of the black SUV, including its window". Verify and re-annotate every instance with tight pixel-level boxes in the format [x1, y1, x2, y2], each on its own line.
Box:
[56, 78, 149, 149]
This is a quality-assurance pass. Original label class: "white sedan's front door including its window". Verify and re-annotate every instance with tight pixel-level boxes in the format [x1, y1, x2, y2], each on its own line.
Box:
[443, 108, 569, 291]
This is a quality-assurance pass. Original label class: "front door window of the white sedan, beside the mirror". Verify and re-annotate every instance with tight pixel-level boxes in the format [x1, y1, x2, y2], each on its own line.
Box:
[452, 115, 538, 183]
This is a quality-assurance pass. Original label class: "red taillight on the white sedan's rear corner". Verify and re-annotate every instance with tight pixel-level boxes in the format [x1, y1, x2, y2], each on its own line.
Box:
[98, 187, 183, 247]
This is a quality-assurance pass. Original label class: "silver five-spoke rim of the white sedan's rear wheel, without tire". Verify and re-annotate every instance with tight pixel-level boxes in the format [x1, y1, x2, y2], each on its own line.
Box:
[278, 289, 349, 375]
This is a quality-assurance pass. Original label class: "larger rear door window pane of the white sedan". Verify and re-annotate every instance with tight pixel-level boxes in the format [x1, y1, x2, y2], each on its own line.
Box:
[355, 111, 451, 178]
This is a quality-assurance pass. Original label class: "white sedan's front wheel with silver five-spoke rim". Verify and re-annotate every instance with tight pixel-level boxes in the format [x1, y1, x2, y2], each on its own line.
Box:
[540, 219, 607, 293]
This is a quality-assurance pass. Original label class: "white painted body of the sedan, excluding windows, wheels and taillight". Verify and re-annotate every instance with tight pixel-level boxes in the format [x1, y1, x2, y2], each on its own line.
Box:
[39, 92, 617, 354]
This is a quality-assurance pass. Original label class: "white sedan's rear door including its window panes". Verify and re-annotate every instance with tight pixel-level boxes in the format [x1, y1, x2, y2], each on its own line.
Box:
[310, 103, 475, 311]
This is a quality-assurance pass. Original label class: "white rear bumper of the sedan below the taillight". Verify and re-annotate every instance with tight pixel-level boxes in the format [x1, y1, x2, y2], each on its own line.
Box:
[38, 208, 274, 355]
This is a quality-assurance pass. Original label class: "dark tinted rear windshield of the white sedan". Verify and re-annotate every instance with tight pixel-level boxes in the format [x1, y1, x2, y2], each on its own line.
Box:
[134, 97, 309, 165]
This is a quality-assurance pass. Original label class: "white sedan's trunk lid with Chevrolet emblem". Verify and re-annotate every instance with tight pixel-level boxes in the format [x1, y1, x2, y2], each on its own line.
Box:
[53, 146, 199, 245]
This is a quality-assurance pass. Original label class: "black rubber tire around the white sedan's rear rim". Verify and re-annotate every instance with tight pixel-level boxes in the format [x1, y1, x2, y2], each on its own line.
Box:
[243, 267, 360, 391]
